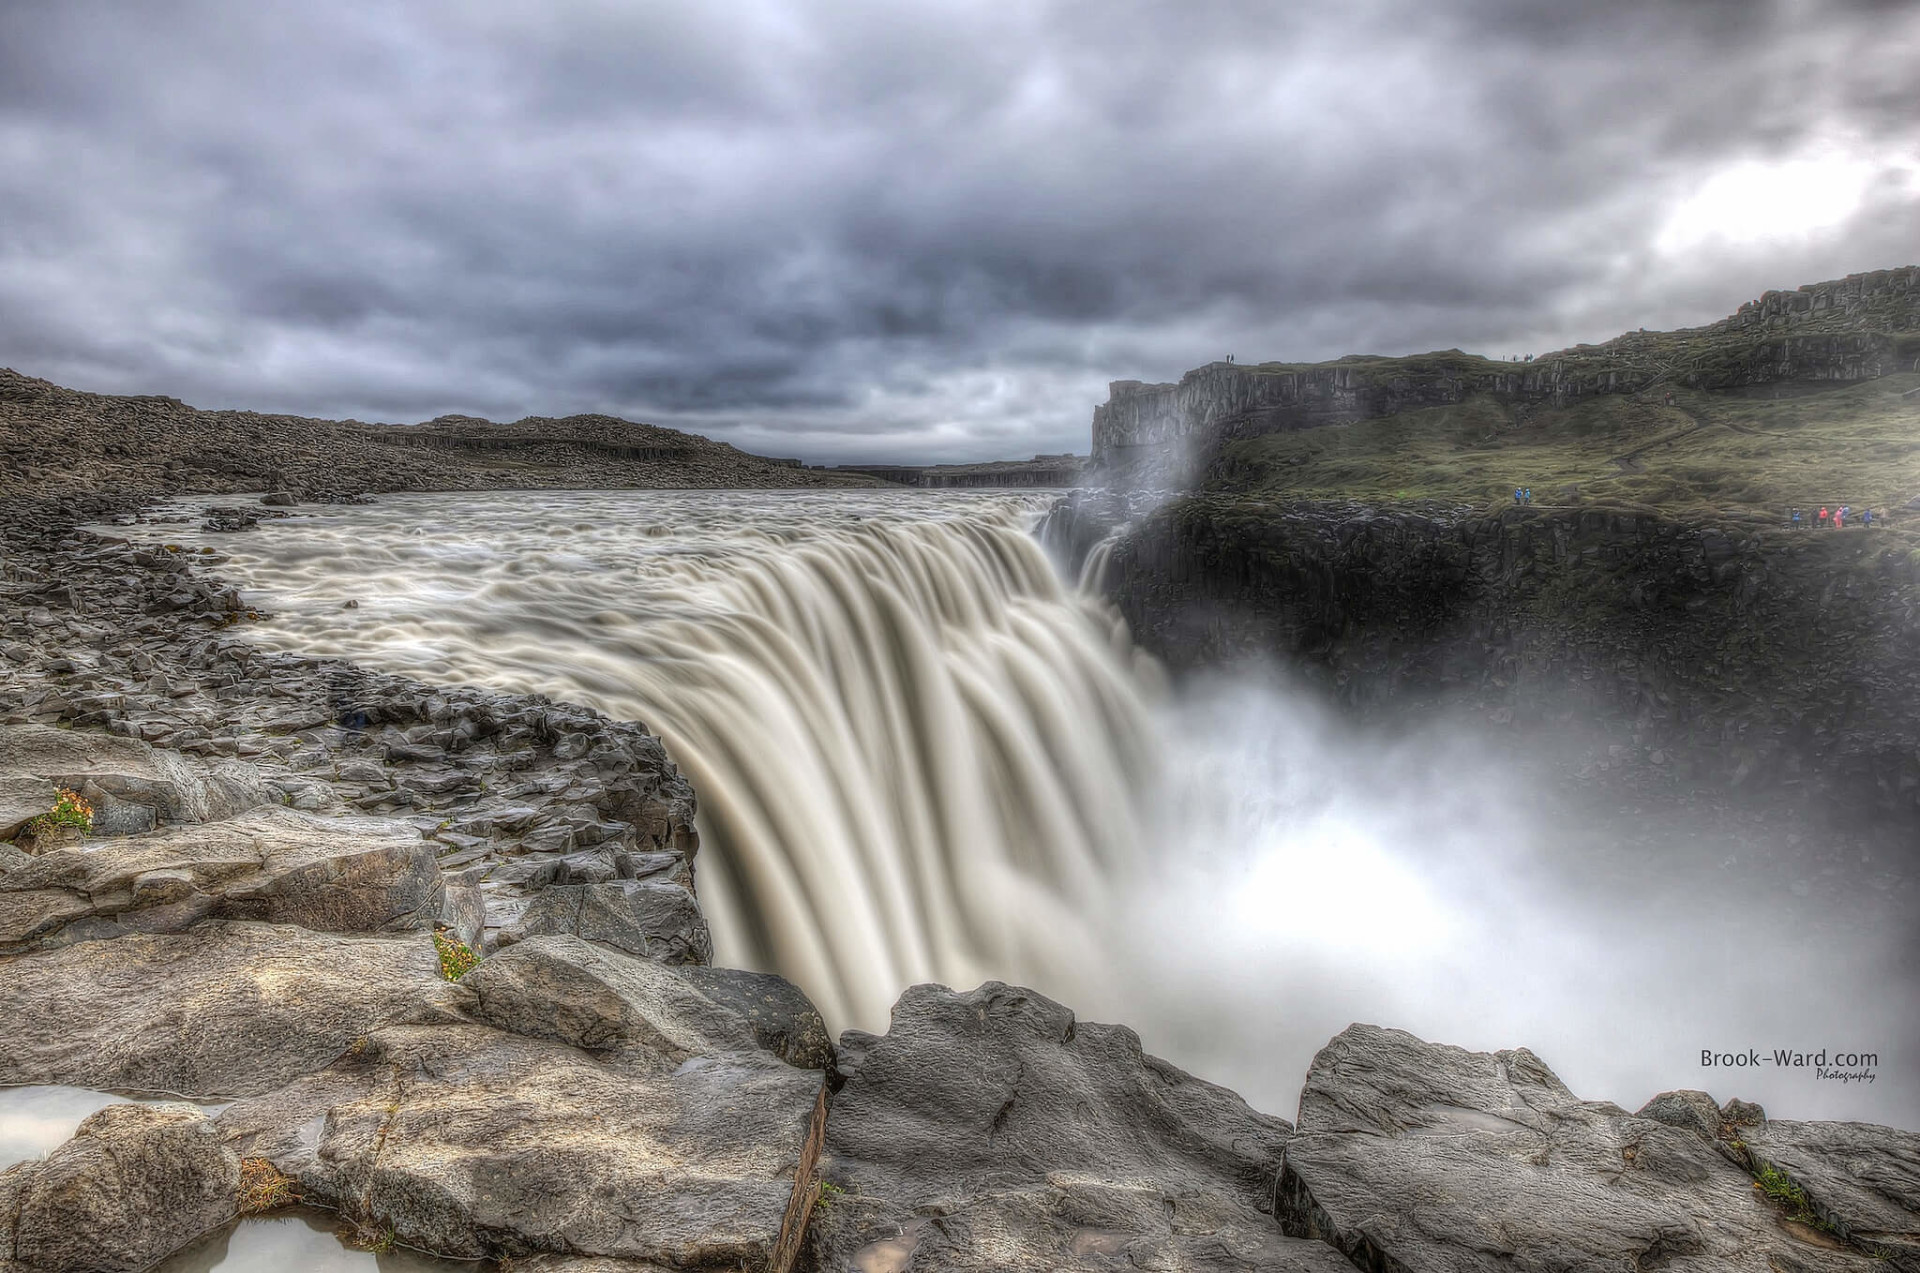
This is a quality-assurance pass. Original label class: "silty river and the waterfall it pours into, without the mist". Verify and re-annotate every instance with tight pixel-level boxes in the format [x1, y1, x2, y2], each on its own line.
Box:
[161, 492, 1156, 1027]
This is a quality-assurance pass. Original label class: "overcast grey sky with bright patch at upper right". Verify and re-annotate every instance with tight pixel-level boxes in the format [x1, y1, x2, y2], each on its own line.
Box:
[0, 0, 1920, 461]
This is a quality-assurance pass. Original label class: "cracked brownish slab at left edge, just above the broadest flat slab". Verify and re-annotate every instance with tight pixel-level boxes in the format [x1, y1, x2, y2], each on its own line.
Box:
[0, 808, 445, 952]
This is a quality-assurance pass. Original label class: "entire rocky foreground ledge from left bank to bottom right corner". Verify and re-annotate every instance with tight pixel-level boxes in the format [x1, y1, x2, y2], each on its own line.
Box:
[0, 503, 1920, 1273]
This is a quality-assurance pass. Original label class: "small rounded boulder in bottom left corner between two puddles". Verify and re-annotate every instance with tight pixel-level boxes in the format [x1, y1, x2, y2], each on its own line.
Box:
[0, 1104, 240, 1273]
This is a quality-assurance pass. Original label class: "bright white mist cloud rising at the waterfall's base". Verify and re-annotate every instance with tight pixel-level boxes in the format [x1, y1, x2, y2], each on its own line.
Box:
[1113, 668, 1920, 1127]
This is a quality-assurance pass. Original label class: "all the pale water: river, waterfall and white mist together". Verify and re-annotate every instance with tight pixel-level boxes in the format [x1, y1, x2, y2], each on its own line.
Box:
[127, 492, 1920, 1125]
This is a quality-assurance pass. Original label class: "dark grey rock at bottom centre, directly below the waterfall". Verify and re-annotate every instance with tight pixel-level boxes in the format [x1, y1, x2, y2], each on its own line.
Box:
[808, 981, 1352, 1273]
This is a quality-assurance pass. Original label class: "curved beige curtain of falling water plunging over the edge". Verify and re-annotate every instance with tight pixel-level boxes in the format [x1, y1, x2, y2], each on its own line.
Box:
[616, 506, 1152, 1025]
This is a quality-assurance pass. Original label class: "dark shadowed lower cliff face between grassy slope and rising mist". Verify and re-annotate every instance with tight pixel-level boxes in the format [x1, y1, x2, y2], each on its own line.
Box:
[1058, 497, 1920, 818]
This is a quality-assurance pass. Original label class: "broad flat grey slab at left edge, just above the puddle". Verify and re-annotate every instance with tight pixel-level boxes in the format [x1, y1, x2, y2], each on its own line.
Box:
[0, 922, 455, 1098]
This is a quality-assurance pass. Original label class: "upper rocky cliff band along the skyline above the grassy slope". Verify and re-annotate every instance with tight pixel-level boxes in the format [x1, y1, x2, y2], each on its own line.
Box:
[1092, 267, 1920, 472]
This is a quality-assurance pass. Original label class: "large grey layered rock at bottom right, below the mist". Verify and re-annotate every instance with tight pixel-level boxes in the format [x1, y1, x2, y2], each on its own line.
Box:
[1279, 1025, 1885, 1273]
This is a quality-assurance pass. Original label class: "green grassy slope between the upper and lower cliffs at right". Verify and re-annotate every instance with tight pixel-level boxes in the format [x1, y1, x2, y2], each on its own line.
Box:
[1210, 374, 1920, 520]
